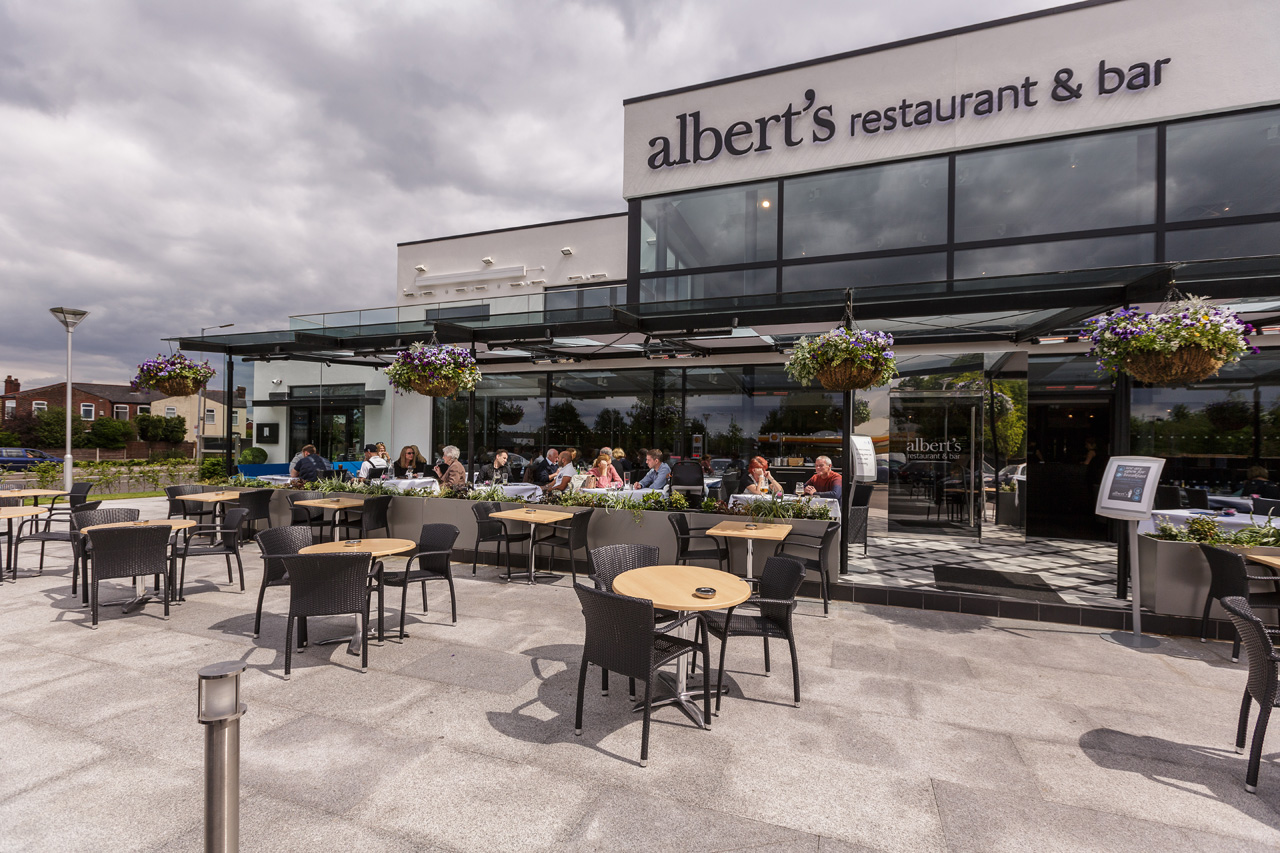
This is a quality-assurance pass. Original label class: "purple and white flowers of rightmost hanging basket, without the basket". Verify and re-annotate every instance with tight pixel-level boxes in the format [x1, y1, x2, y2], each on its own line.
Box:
[1087, 296, 1258, 373]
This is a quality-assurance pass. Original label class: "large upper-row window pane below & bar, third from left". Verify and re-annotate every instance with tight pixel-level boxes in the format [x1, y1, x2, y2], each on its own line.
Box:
[955, 128, 1156, 240]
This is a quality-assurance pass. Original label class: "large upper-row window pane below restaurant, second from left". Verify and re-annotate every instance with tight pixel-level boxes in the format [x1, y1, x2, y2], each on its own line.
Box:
[782, 158, 947, 257]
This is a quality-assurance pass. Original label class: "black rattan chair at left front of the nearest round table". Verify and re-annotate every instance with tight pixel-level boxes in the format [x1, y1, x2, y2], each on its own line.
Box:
[573, 584, 712, 767]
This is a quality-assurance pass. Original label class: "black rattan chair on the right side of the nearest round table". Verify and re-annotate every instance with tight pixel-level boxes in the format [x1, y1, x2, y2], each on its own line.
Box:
[704, 557, 804, 711]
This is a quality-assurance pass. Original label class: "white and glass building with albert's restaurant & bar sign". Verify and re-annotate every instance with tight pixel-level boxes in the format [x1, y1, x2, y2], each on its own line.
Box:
[182, 0, 1280, 563]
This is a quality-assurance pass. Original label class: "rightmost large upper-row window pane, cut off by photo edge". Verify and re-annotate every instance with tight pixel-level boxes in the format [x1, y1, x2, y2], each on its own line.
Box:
[1165, 110, 1280, 220]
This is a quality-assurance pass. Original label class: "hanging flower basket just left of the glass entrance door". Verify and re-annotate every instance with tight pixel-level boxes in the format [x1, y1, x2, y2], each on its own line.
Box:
[786, 328, 897, 391]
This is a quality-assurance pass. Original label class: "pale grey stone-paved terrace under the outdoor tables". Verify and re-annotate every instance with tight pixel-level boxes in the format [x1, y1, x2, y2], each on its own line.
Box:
[0, 500, 1280, 853]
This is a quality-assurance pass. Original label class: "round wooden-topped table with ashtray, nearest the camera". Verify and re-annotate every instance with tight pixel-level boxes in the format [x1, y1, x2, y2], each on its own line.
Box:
[613, 566, 751, 729]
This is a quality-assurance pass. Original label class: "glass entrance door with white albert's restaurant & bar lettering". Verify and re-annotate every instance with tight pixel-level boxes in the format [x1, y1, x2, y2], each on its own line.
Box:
[888, 389, 986, 537]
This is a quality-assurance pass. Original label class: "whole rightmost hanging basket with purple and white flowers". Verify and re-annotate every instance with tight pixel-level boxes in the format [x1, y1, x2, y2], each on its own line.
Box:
[1087, 296, 1258, 386]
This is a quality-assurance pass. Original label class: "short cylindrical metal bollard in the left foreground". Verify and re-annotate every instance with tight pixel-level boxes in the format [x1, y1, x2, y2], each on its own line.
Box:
[196, 661, 248, 853]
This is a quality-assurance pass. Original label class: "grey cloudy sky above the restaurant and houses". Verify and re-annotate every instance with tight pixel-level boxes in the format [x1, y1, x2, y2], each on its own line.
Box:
[0, 0, 1059, 387]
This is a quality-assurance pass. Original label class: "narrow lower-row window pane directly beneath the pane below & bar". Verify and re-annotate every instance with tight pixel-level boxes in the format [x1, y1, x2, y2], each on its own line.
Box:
[955, 234, 1156, 279]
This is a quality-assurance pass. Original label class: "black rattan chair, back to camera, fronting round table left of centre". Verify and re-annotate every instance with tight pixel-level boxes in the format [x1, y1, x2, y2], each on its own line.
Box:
[276, 550, 372, 680]
